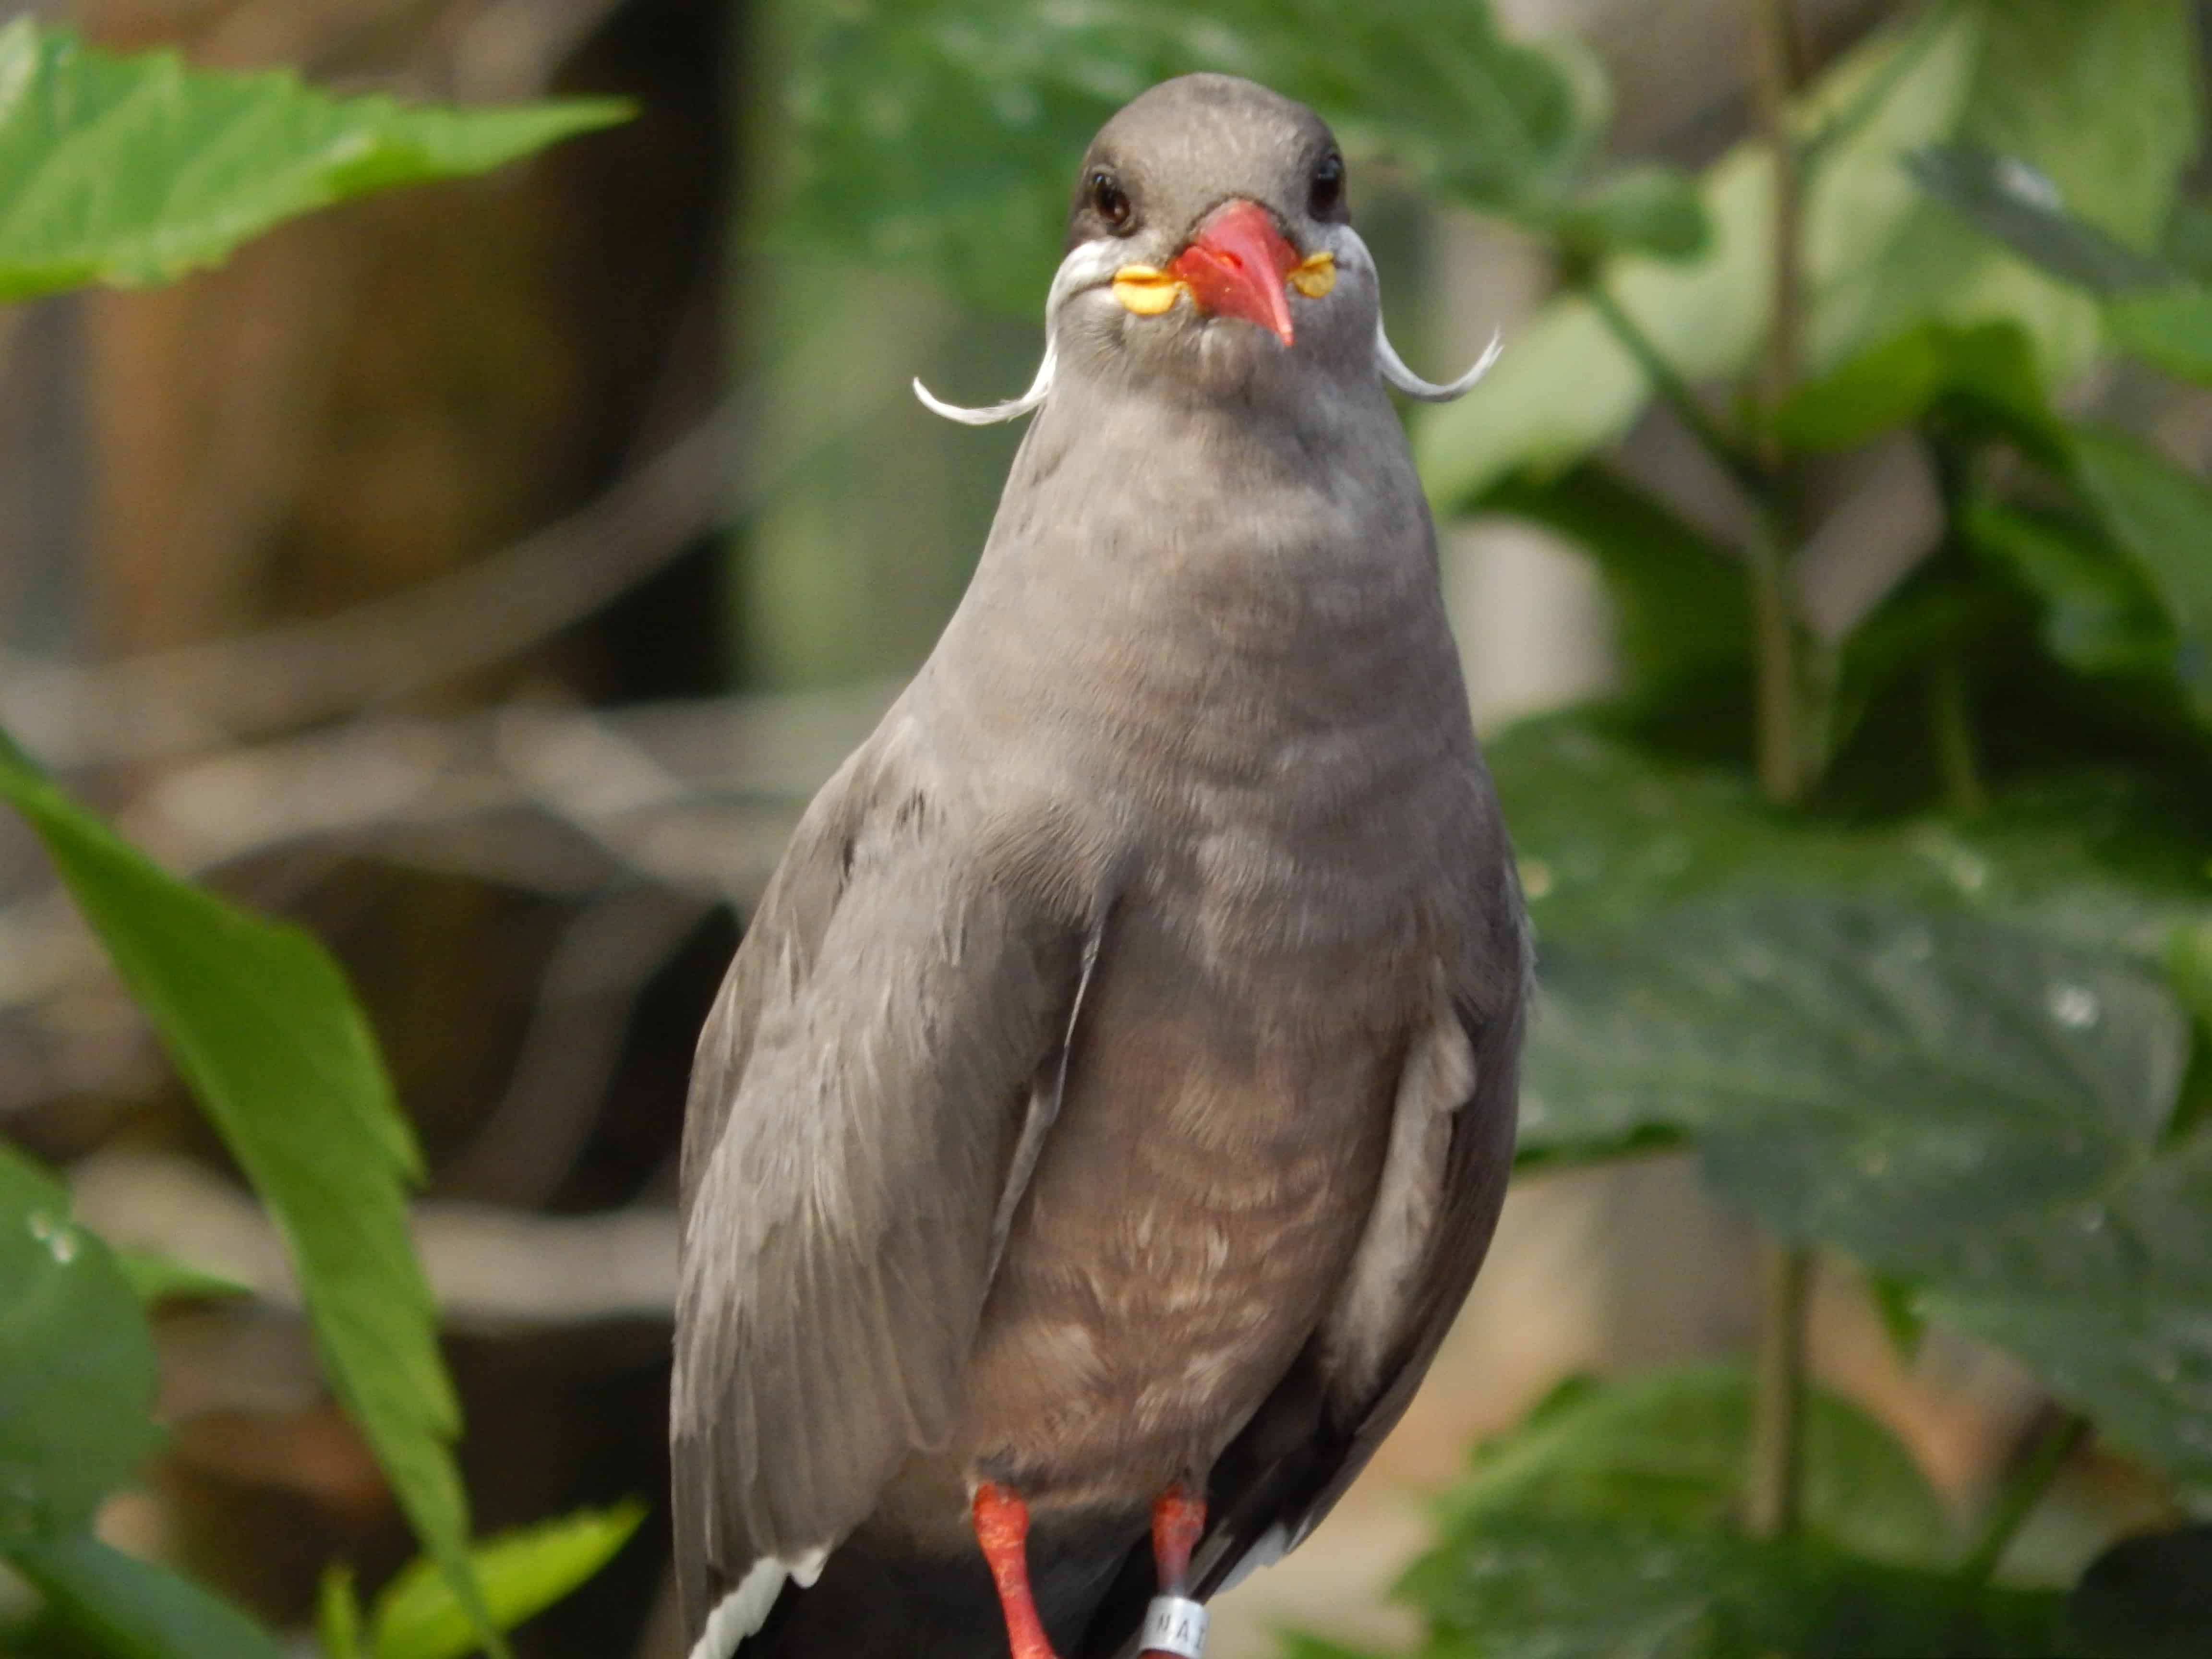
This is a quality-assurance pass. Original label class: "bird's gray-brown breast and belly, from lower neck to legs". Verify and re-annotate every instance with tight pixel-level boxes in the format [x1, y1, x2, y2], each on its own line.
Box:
[871, 387, 1473, 1548]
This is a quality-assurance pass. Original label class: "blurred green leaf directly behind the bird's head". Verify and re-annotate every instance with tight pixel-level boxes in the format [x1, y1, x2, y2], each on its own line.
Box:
[785, 0, 1584, 312]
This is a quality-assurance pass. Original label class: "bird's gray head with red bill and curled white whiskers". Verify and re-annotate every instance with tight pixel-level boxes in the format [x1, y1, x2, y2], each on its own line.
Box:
[914, 75, 1495, 425]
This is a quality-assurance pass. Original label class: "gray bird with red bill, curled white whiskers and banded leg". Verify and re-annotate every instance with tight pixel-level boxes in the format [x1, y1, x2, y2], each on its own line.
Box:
[673, 75, 1528, 1659]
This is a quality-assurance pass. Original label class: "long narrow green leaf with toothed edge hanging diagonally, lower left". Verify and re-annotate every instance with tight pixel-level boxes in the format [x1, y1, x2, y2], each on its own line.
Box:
[0, 736, 497, 1654]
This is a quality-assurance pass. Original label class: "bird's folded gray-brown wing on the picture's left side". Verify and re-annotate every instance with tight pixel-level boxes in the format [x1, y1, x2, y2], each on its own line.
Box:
[673, 761, 1082, 1628]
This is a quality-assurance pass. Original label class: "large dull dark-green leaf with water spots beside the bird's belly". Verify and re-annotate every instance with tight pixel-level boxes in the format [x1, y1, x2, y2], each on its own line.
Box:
[1528, 887, 2212, 1500]
